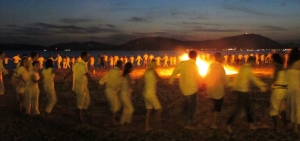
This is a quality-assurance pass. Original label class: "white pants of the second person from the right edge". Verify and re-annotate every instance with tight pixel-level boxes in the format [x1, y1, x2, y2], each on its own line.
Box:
[270, 89, 286, 116]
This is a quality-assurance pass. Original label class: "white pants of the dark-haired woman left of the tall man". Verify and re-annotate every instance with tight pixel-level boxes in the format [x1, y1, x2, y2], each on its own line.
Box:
[44, 86, 57, 113]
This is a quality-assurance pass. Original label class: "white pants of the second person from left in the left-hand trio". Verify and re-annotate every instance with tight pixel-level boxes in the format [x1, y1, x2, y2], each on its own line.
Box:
[24, 86, 40, 115]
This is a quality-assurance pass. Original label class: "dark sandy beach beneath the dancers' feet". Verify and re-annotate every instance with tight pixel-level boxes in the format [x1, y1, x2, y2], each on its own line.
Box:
[0, 65, 299, 141]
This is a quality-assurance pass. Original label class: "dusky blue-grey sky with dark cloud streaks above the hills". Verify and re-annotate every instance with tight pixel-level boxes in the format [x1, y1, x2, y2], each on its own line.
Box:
[0, 0, 300, 46]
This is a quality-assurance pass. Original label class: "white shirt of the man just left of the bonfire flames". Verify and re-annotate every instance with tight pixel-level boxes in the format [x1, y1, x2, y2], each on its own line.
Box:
[169, 59, 201, 96]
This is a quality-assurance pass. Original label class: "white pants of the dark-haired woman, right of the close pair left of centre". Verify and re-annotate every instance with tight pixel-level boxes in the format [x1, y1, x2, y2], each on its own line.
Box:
[120, 92, 134, 124]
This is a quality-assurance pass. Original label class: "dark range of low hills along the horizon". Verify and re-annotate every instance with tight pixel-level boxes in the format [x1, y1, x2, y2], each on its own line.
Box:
[0, 34, 300, 51]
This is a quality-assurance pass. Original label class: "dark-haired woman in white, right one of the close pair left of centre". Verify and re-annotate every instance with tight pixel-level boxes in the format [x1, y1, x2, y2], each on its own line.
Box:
[120, 63, 134, 125]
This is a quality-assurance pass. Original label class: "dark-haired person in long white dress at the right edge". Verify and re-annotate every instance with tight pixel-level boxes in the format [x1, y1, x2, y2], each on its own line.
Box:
[286, 47, 300, 133]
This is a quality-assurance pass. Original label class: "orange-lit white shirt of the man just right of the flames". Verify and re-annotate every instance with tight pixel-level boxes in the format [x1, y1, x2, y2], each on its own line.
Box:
[205, 62, 229, 99]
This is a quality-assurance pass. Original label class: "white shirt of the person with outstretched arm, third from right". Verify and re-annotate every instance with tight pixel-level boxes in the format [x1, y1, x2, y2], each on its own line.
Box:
[233, 63, 266, 92]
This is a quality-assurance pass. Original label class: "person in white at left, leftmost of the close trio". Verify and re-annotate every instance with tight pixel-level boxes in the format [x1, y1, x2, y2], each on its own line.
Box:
[13, 57, 29, 112]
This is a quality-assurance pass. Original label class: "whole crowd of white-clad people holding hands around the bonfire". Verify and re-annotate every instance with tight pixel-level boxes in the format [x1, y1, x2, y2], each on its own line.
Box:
[0, 48, 300, 133]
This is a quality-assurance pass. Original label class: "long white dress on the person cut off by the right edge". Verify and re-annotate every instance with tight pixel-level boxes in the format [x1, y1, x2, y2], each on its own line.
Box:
[286, 61, 300, 124]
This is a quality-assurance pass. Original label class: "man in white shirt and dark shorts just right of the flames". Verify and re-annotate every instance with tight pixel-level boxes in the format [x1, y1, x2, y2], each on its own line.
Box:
[205, 53, 230, 129]
